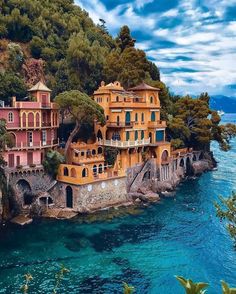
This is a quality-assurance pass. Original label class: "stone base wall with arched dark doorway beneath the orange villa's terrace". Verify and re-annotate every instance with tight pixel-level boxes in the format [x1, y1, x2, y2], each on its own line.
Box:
[50, 177, 130, 212]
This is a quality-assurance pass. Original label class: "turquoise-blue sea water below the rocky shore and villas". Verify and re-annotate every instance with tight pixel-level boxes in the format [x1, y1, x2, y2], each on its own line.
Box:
[0, 114, 236, 294]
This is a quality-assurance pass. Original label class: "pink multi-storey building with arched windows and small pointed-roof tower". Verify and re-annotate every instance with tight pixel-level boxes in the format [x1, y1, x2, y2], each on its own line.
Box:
[0, 82, 59, 169]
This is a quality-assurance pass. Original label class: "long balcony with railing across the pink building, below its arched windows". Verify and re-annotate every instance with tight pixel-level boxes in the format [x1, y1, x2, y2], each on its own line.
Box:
[6, 139, 59, 151]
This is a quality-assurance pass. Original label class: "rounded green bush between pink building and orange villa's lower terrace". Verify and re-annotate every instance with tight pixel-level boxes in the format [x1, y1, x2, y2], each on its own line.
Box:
[43, 150, 65, 179]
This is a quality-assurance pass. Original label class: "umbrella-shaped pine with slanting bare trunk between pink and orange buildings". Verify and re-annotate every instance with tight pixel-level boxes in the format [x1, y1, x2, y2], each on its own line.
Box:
[55, 90, 105, 161]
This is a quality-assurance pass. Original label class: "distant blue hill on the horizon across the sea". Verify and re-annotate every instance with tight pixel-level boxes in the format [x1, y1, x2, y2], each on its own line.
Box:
[210, 95, 236, 113]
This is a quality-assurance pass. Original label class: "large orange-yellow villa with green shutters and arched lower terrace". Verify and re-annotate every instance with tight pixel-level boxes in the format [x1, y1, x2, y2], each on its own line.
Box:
[58, 82, 170, 185]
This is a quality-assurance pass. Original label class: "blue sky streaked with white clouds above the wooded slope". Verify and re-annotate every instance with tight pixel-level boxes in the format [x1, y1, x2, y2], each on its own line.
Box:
[75, 0, 236, 97]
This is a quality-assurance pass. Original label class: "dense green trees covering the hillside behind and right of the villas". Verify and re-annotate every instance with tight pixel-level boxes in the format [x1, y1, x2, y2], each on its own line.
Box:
[0, 0, 236, 150]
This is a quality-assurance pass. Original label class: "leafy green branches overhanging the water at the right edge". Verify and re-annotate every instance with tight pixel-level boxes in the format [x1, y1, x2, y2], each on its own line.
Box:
[215, 192, 236, 245]
